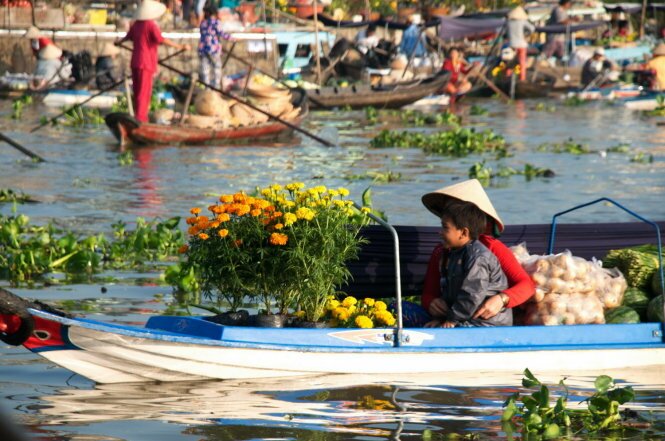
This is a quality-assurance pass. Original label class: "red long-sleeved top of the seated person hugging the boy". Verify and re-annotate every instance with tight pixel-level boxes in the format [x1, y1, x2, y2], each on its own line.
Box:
[421, 234, 536, 311]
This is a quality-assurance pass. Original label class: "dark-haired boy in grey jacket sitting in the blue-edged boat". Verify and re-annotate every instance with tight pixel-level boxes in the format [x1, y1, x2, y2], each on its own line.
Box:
[428, 199, 513, 328]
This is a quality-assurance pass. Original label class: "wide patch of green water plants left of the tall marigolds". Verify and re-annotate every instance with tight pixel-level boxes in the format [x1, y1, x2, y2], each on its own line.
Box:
[0, 214, 184, 285]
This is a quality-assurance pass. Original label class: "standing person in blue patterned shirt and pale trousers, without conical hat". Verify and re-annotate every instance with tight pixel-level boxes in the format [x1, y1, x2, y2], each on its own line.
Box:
[199, 3, 231, 89]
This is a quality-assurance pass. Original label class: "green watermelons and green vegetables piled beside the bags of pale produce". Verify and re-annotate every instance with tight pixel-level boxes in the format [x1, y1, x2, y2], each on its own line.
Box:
[603, 245, 663, 323]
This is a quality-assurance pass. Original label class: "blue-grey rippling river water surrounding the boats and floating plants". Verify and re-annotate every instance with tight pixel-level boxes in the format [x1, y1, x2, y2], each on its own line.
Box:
[0, 95, 665, 441]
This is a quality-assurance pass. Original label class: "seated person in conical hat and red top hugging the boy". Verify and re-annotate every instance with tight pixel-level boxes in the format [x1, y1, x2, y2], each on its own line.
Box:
[402, 179, 536, 327]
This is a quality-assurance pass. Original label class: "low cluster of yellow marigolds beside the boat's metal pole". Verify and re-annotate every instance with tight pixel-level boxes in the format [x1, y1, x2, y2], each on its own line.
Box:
[325, 296, 396, 328]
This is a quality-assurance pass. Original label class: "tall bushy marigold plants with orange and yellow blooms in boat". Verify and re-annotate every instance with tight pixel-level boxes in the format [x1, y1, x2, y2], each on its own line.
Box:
[179, 183, 368, 321]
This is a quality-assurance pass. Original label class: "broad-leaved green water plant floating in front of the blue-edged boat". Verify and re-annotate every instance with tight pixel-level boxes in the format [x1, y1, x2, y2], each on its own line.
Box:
[501, 369, 635, 440]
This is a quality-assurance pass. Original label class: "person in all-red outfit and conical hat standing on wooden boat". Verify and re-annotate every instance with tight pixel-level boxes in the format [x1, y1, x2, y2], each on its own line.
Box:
[117, 0, 190, 122]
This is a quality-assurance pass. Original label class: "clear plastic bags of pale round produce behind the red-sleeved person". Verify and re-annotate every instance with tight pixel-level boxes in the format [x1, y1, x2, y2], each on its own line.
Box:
[512, 245, 626, 325]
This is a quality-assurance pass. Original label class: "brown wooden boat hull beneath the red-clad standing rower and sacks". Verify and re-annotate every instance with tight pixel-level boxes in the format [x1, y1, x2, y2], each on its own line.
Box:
[104, 89, 307, 146]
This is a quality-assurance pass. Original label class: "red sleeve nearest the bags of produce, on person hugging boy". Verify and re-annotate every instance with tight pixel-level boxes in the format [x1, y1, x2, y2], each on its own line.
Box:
[480, 234, 536, 308]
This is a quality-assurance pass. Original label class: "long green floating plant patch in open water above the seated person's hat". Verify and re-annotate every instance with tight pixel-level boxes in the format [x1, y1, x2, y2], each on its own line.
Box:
[370, 127, 506, 157]
